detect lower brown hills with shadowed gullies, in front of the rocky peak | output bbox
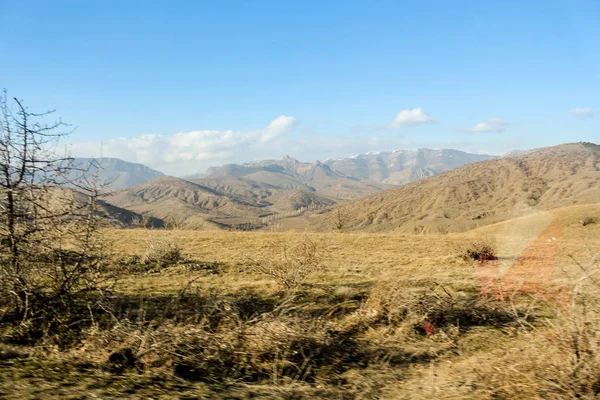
[103,176,336,230]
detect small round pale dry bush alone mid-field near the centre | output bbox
[251,236,327,289]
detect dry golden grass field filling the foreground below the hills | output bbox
[0,205,600,399]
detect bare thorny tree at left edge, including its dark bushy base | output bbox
[0,92,116,346]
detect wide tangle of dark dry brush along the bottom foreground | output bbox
[74,293,372,386]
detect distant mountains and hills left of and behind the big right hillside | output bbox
[95,149,495,229]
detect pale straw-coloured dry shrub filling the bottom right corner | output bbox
[412,254,600,399]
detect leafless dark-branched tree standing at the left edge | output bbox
[0,91,112,319]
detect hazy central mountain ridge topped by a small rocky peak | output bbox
[103,157,391,229]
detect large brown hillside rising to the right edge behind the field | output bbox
[313,143,600,233]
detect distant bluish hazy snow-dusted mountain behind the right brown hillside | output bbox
[324,149,497,185]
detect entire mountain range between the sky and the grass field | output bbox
[86,143,600,232]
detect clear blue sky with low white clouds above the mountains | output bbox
[0,0,600,175]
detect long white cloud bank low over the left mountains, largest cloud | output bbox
[71,115,299,176]
